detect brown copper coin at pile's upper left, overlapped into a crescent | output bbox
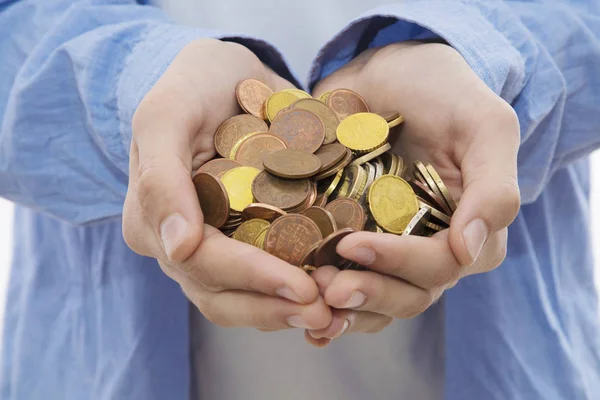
[215,114,269,158]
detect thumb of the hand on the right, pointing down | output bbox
[450,100,520,265]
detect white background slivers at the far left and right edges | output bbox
[0,152,600,335]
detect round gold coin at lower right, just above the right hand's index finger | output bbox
[368,175,419,234]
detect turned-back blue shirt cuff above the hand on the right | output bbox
[307,0,525,103]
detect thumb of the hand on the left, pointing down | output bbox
[130,110,204,262]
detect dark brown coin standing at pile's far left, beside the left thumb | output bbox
[194,172,229,228]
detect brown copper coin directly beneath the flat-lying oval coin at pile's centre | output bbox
[252,171,311,210]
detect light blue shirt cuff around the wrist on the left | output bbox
[117,24,300,166]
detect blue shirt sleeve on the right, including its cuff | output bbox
[309,0,600,203]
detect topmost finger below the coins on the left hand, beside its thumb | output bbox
[173,225,319,303]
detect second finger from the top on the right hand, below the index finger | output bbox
[325,271,442,318]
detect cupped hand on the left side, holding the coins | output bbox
[123,39,331,330]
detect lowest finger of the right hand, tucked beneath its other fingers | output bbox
[308,309,393,339]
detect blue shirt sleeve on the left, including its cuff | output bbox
[0,0,296,224]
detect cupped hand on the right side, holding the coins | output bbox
[306,42,520,345]
